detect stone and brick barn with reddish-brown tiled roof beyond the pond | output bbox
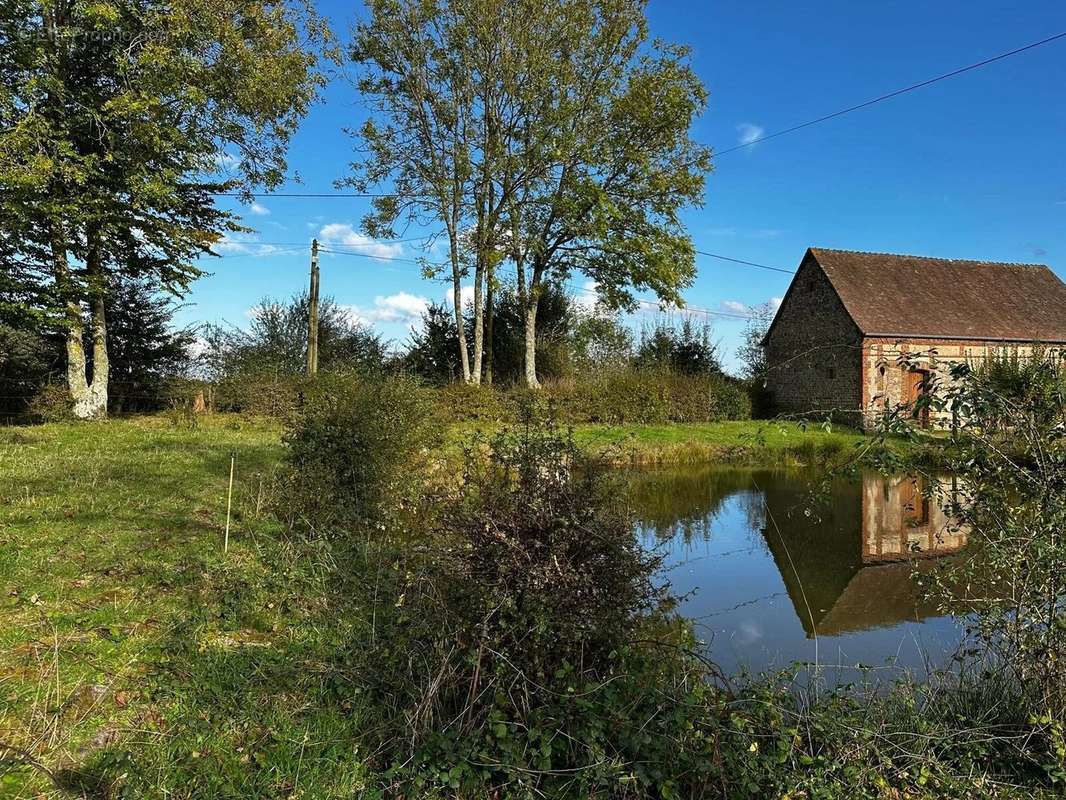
[762,247,1066,425]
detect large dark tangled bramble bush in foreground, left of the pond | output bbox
[361,422,713,797]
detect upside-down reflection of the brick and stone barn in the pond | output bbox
[763,476,966,636]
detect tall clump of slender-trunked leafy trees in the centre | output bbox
[352,0,710,385]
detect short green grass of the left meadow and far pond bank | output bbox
[0,416,861,798]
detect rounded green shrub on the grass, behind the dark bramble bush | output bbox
[280,375,439,531]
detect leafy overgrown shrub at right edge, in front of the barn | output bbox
[861,351,1066,721]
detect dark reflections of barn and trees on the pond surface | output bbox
[630,467,966,636]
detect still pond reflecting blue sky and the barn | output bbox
[630,467,966,681]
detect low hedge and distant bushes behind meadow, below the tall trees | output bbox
[0,281,750,422]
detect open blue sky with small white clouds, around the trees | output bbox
[179,0,1066,375]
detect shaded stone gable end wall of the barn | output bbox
[766,257,863,421]
